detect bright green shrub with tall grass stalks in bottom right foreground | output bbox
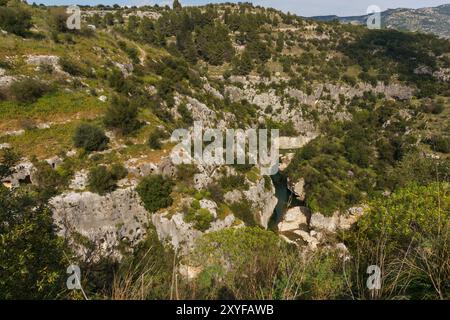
[346,183,450,299]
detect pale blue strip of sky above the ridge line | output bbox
[32,0,450,16]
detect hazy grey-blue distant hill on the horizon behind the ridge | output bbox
[313,4,450,38]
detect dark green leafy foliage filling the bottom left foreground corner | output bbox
[0,185,70,299]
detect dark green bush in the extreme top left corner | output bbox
[0,7,33,36]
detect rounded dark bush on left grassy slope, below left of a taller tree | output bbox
[73,123,109,151]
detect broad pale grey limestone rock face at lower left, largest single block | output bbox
[50,188,148,260]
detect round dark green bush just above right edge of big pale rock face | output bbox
[136,175,173,213]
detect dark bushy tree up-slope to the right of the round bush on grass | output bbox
[103,96,141,134]
